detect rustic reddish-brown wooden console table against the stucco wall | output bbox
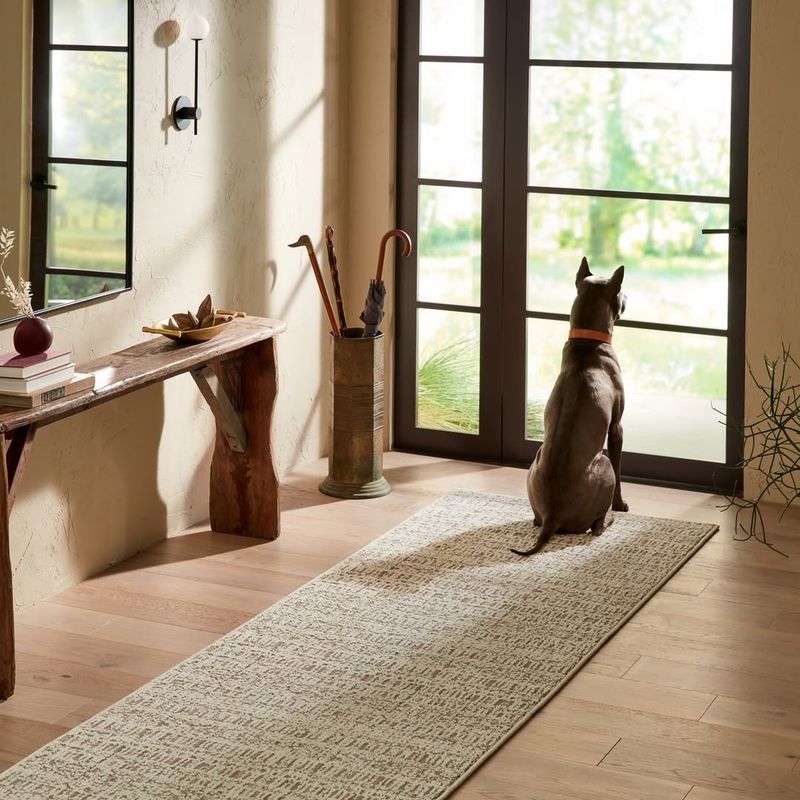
[0,317,286,700]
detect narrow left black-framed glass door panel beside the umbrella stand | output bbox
[394,0,506,458]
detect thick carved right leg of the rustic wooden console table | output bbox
[204,338,280,539]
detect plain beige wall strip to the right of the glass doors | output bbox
[745,0,800,495]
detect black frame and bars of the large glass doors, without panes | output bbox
[393,0,752,492]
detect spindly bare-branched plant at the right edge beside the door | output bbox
[721,344,800,555]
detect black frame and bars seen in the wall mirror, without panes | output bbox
[29,0,135,314]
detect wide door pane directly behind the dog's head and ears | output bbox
[528,194,728,328]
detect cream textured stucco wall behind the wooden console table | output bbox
[6,0,343,606]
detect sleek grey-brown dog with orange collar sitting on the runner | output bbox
[513,258,628,556]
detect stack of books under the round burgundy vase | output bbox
[0,349,94,408]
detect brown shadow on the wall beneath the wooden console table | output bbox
[12,384,167,606]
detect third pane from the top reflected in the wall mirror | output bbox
[47,164,126,273]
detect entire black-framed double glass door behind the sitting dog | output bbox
[394,0,750,490]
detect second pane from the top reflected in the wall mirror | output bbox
[50,50,128,161]
